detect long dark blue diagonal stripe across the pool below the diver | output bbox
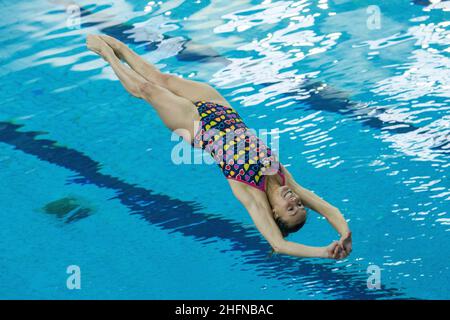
[0,121,410,299]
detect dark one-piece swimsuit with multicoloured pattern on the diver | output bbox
[192,101,285,191]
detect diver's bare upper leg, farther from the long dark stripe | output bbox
[101,35,228,104]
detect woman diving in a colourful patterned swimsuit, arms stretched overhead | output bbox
[87,35,352,259]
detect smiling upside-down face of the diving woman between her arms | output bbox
[273,186,306,226]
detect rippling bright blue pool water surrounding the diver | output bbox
[0,0,450,299]
